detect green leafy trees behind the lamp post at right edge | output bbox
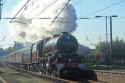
[96,37,125,63]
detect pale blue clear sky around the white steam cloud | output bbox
[0,0,125,48]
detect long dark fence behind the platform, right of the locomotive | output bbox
[84,56,125,69]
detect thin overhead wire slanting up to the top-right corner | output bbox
[85,0,125,17]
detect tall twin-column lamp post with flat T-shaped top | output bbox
[95,15,118,67]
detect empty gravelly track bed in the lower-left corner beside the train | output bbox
[0,61,48,83]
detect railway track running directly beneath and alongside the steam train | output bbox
[6,63,106,83]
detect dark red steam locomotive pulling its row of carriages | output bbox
[6,32,97,80]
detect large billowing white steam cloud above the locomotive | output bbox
[10,0,77,42]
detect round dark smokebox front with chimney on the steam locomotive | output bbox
[56,32,78,56]
